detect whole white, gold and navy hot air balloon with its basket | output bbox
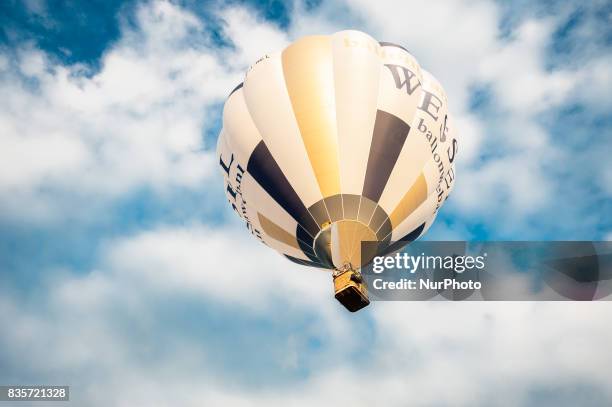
[217,30,457,311]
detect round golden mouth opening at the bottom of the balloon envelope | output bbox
[314,219,378,271]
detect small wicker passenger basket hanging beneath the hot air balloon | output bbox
[332,263,370,312]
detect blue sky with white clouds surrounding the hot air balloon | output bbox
[0,0,612,406]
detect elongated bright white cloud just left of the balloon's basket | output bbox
[101,227,331,308]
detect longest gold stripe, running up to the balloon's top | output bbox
[282,36,340,198]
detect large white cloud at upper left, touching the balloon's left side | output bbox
[0,1,274,220]
